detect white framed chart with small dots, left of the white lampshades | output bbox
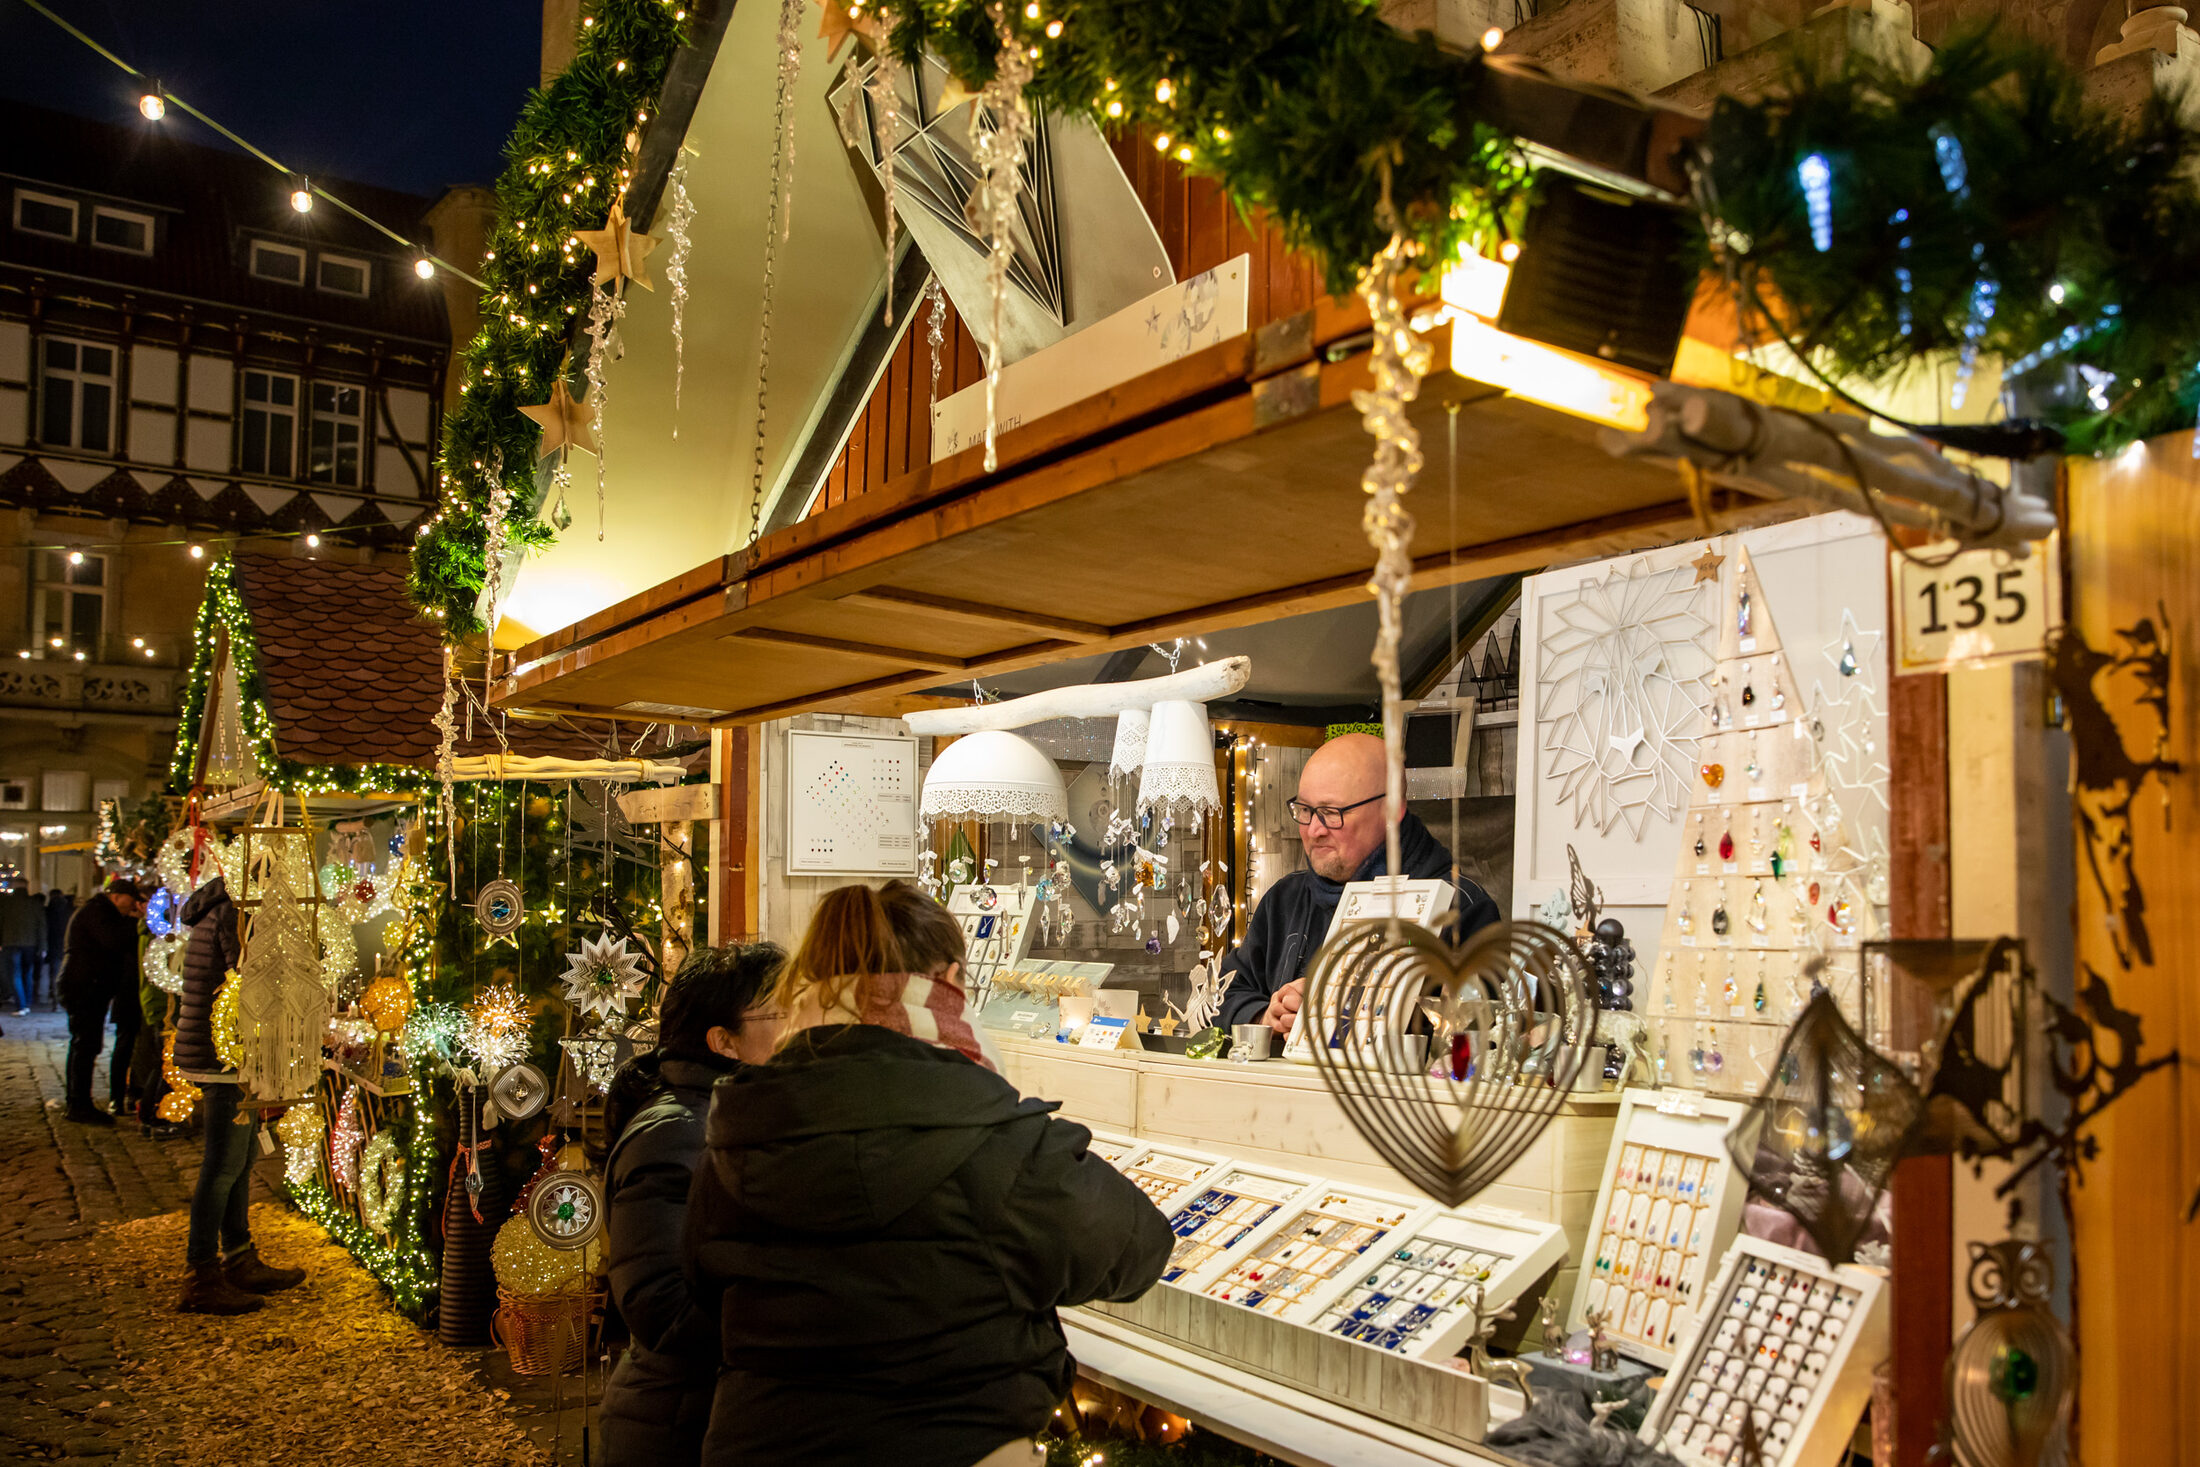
[788,732,917,875]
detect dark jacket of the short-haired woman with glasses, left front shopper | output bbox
[601,1054,737,1467]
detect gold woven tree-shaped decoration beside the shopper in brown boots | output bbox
[238,829,330,1102]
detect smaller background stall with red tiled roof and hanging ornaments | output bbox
[163,554,697,1370]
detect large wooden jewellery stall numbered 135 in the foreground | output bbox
[409,0,2200,1467]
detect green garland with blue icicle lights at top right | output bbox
[1703,31,2200,453]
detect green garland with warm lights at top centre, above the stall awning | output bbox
[873,0,1527,295]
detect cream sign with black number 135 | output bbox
[1890,537,2061,673]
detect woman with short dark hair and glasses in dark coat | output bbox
[598,941,785,1467]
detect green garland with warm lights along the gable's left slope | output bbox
[409,0,686,640]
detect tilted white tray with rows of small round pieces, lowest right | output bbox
[1641,1238,1888,1467]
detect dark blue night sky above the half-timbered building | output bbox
[0,0,541,196]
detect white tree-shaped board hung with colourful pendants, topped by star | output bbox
[1643,541,1863,1093]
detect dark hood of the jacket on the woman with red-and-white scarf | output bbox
[706,1025,1056,1234]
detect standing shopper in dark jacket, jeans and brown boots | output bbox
[176,875,306,1315]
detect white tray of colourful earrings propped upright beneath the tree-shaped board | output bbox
[1566,1091,1745,1366]
